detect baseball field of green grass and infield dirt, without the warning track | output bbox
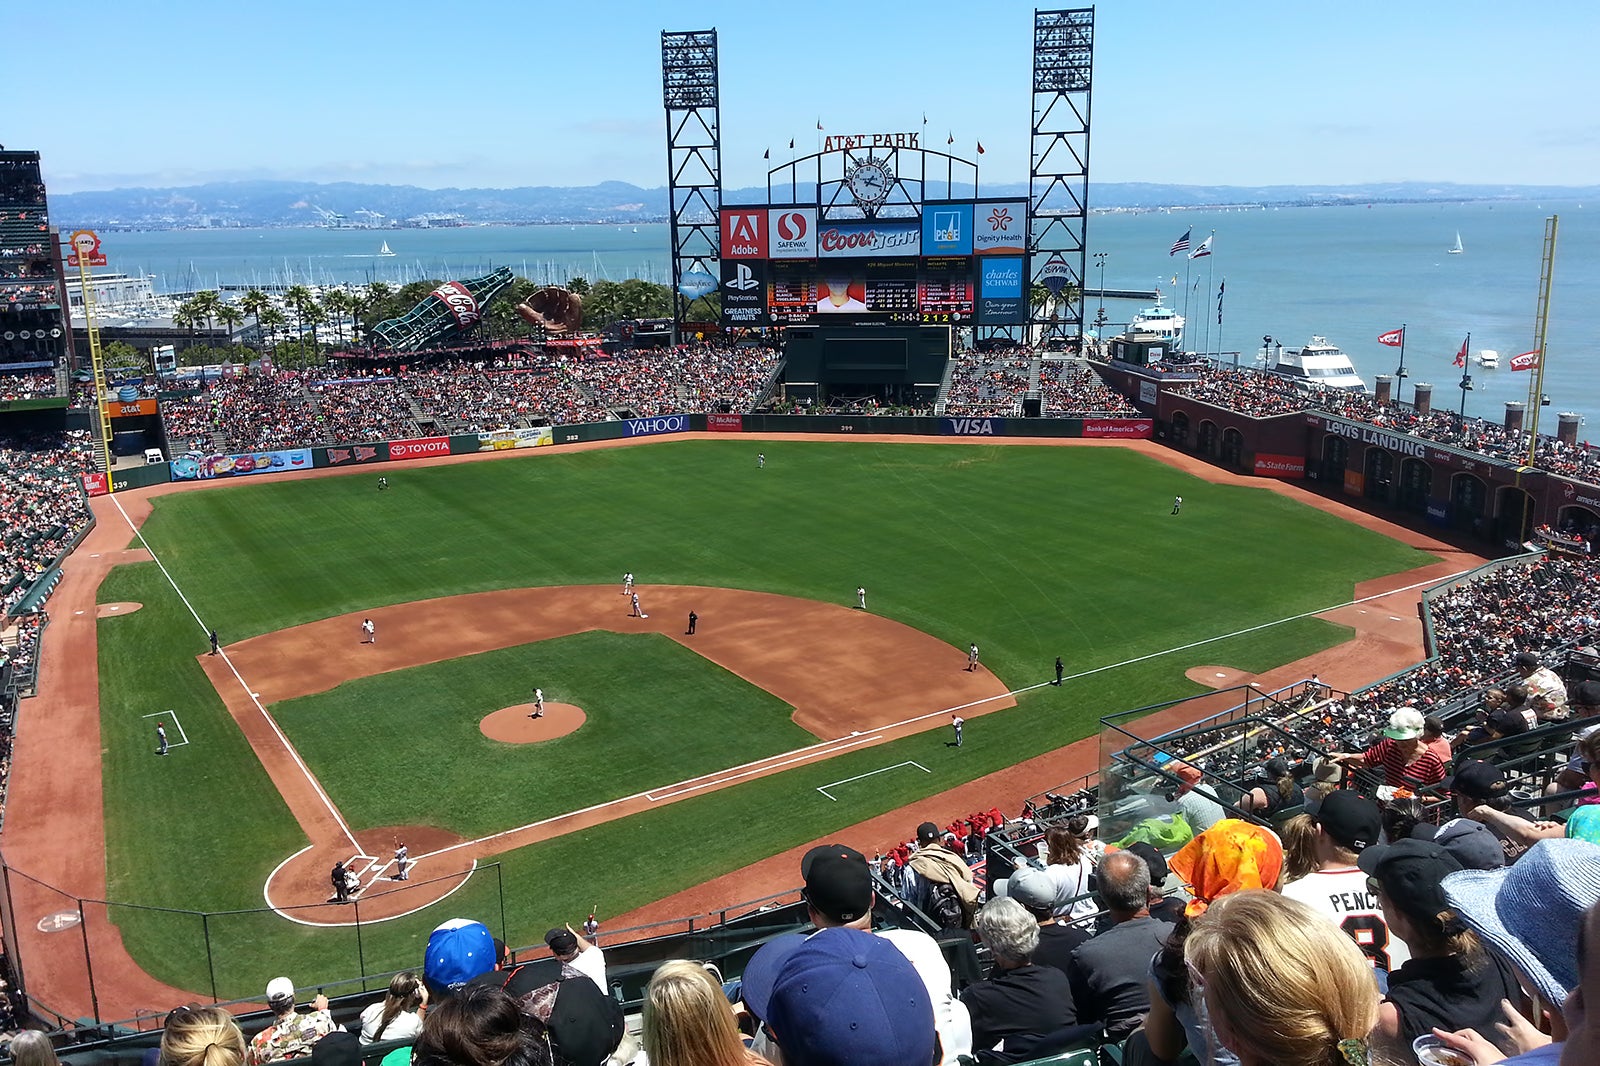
[75,440,1432,997]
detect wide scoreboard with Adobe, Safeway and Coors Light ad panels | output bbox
[720,200,1027,328]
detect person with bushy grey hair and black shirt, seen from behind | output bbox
[962,882,1075,1063]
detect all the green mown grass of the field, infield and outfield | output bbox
[99,440,1432,994]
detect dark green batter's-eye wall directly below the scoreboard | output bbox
[782,325,950,407]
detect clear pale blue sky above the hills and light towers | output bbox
[15,0,1600,192]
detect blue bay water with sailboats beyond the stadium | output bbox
[93,202,1600,425]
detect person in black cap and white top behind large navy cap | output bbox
[790,844,966,1066]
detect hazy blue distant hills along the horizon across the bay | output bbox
[50,181,1600,229]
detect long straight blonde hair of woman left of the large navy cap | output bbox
[643,959,766,1066]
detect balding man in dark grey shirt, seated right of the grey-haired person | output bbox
[1069,852,1173,1042]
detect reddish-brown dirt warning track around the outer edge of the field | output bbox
[0,434,1485,1018]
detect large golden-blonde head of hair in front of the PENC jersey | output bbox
[1184,890,1378,1066]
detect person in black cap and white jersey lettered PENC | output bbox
[1283,787,1421,981]
